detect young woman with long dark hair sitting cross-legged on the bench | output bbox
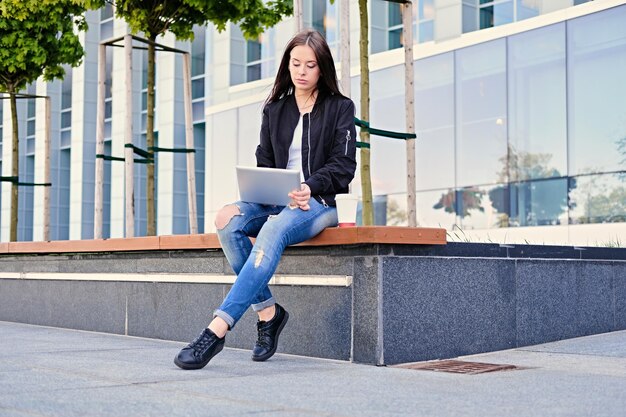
[174,30,356,369]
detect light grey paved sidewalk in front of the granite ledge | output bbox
[0,322,626,417]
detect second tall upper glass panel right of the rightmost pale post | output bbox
[456,39,507,187]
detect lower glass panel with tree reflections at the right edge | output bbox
[569,174,626,224]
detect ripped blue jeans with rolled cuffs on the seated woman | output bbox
[214,198,337,329]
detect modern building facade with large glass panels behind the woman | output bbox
[0,0,626,243]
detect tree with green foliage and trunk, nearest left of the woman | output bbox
[115,0,292,236]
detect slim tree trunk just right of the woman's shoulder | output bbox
[359,0,374,226]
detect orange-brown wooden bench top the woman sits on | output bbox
[0,226,446,255]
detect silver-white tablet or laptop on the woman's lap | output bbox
[236,165,300,206]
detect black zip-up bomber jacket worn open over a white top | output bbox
[256,94,356,206]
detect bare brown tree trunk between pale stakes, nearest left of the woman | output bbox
[146,36,156,236]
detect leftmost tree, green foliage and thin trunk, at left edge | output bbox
[0,0,90,241]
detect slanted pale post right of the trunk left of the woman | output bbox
[183,53,198,234]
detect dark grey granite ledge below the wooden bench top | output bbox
[0,240,626,365]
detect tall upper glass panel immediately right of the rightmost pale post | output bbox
[414,52,454,190]
